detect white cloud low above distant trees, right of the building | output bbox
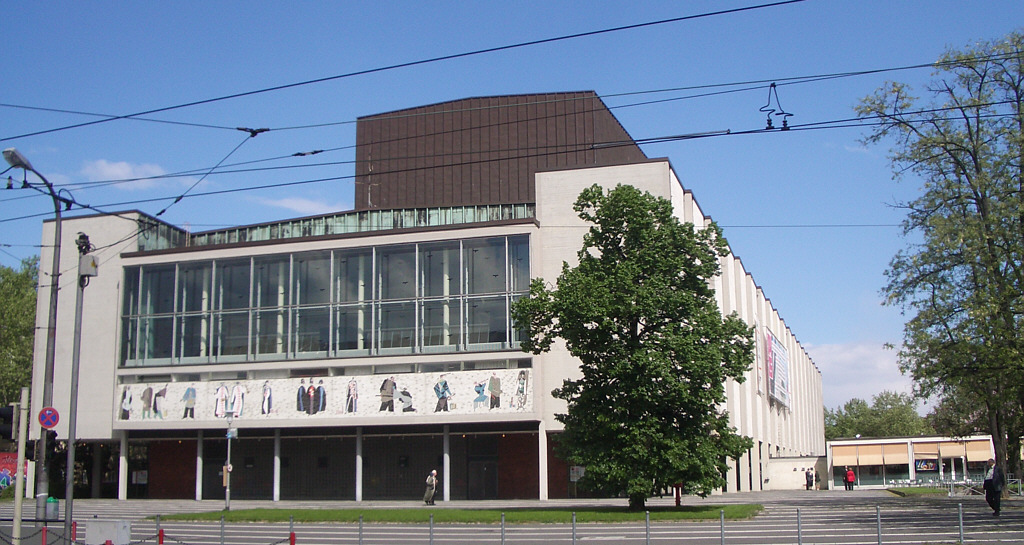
[806,342,922,411]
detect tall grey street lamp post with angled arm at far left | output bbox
[3,148,65,520]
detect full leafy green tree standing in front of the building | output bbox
[513,185,754,508]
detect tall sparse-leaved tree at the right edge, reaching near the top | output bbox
[857,32,1024,473]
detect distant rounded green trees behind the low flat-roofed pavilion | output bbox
[825,390,935,441]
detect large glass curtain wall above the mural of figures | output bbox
[121,235,530,367]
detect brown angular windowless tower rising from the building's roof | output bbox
[354,91,647,210]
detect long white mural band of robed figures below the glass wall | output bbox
[117,369,532,425]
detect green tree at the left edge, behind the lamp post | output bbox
[0,257,39,406]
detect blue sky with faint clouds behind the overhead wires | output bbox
[0,0,1024,408]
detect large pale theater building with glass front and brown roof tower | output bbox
[33,92,825,501]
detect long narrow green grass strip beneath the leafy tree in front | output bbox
[161,504,763,523]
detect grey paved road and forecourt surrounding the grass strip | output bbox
[0,491,1024,545]
